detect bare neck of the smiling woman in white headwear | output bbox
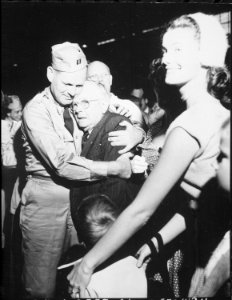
[180,69,212,108]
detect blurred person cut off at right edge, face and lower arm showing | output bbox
[188,118,231,297]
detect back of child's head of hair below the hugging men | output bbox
[73,194,118,248]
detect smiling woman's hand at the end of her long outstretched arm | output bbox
[67,260,92,299]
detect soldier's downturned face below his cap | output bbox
[51,68,86,106]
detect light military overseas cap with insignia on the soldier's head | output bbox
[52,42,87,73]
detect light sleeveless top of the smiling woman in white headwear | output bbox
[166,97,229,198]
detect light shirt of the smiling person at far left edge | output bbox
[1,119,21,167]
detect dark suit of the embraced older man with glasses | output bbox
[71,111,142,223]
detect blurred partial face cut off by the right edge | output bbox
[217,119,230,192]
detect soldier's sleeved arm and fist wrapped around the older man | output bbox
[22,106,131,181]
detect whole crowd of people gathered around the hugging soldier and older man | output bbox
[1,13,230,300]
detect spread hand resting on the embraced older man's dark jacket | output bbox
[108,121,144,154]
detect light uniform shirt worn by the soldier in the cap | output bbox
[22,88,106,180]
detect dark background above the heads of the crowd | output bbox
[1,1,231,103]
